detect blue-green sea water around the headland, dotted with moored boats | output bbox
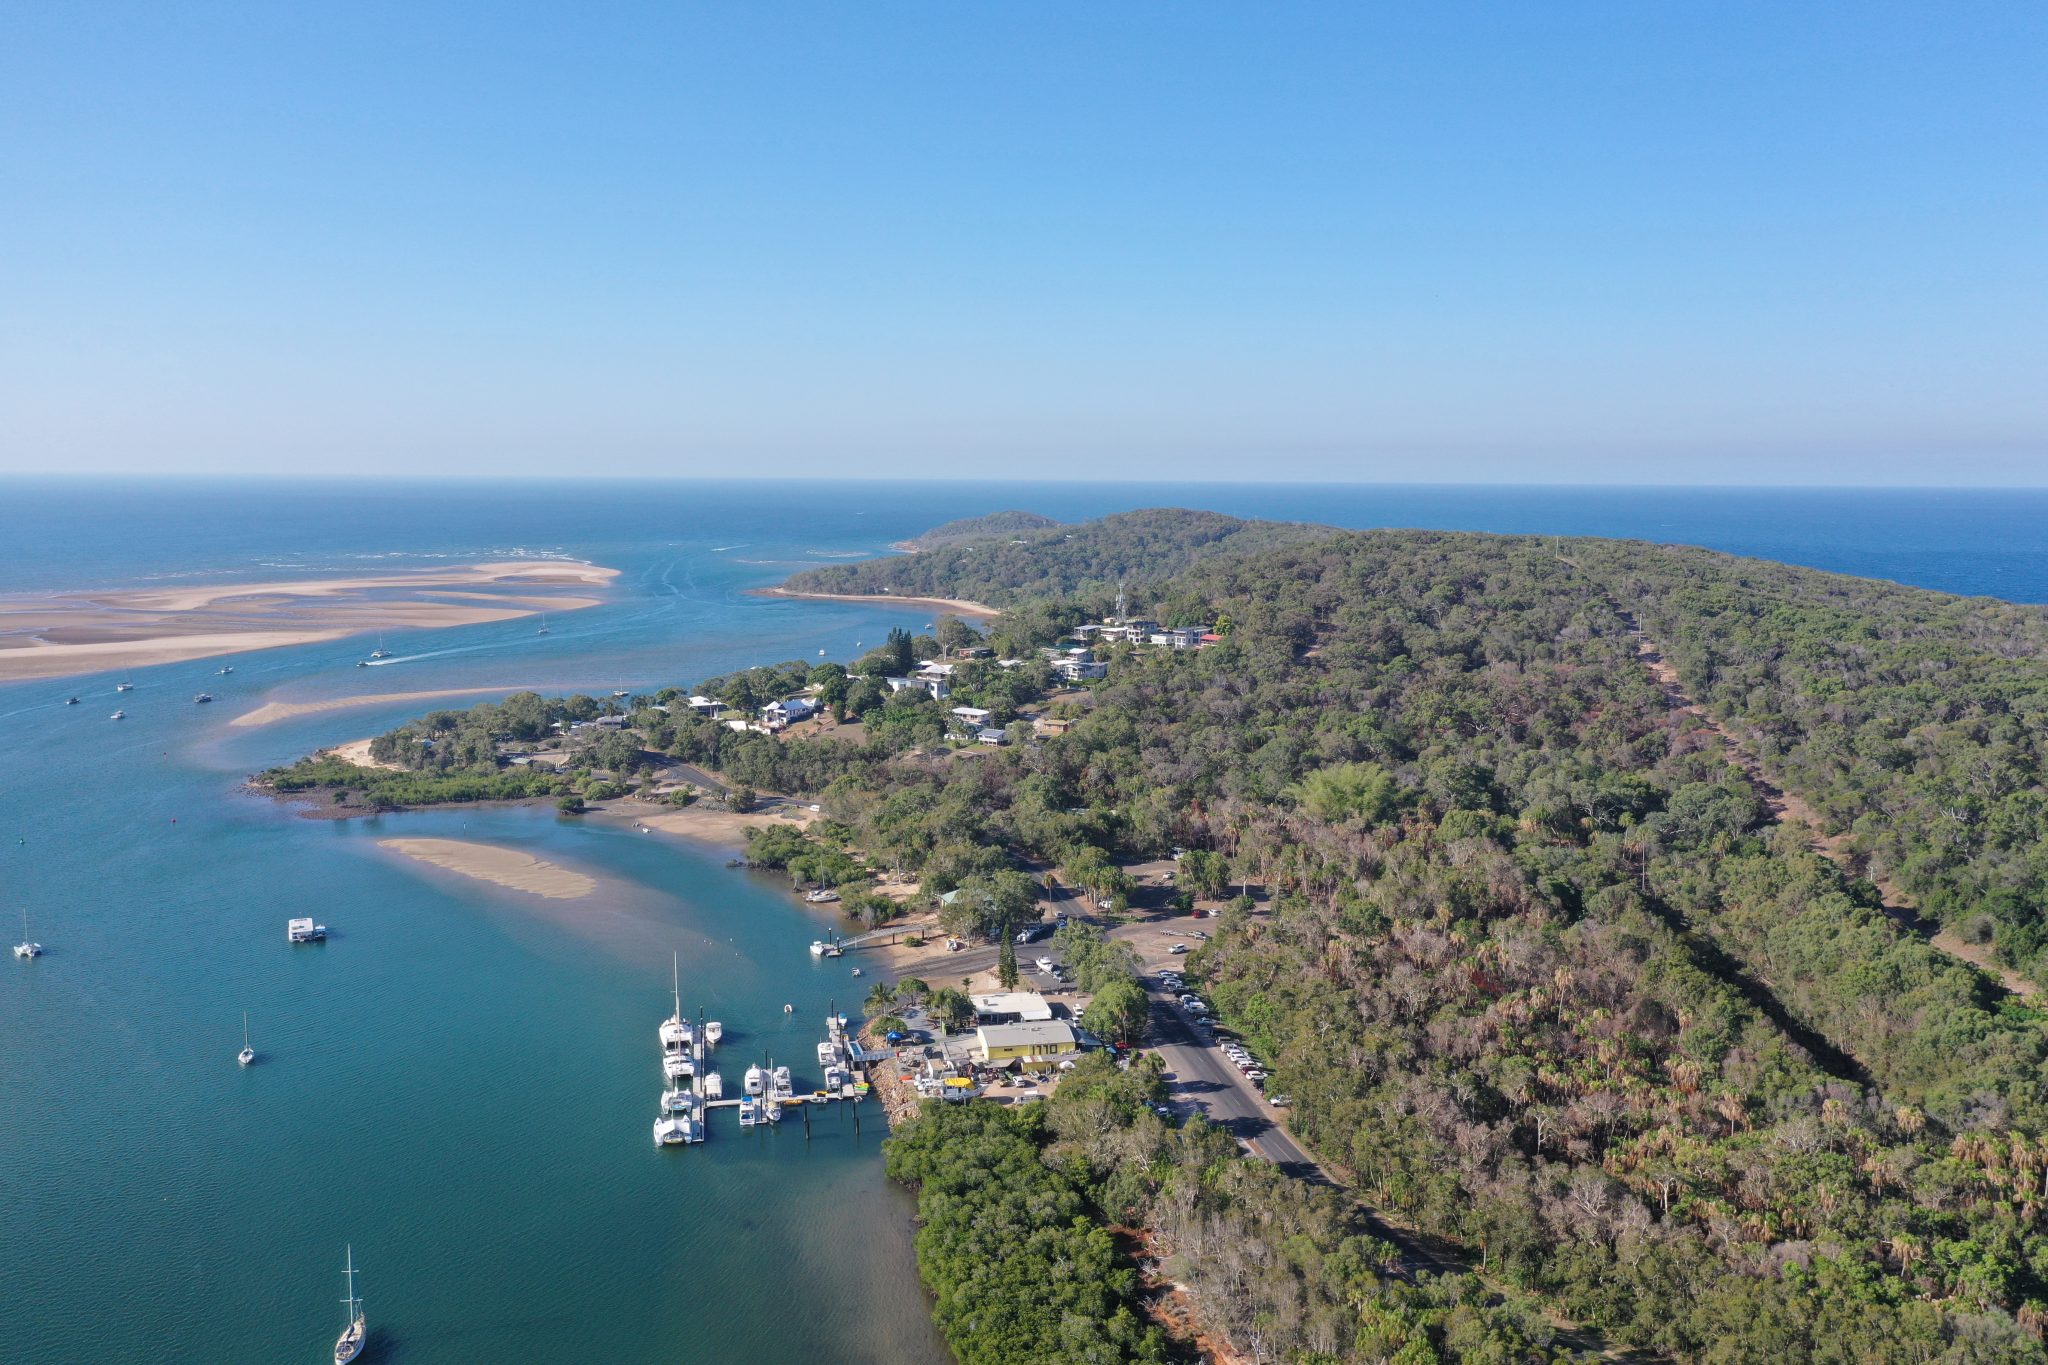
[0,474,2048,1365]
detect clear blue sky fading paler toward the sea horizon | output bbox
[0,0,2048,483]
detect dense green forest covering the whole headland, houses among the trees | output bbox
[264,512,2048,1365]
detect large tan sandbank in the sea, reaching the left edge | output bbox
[0,559,618,681]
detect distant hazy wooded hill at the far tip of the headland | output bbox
[784,508,1335,606]
